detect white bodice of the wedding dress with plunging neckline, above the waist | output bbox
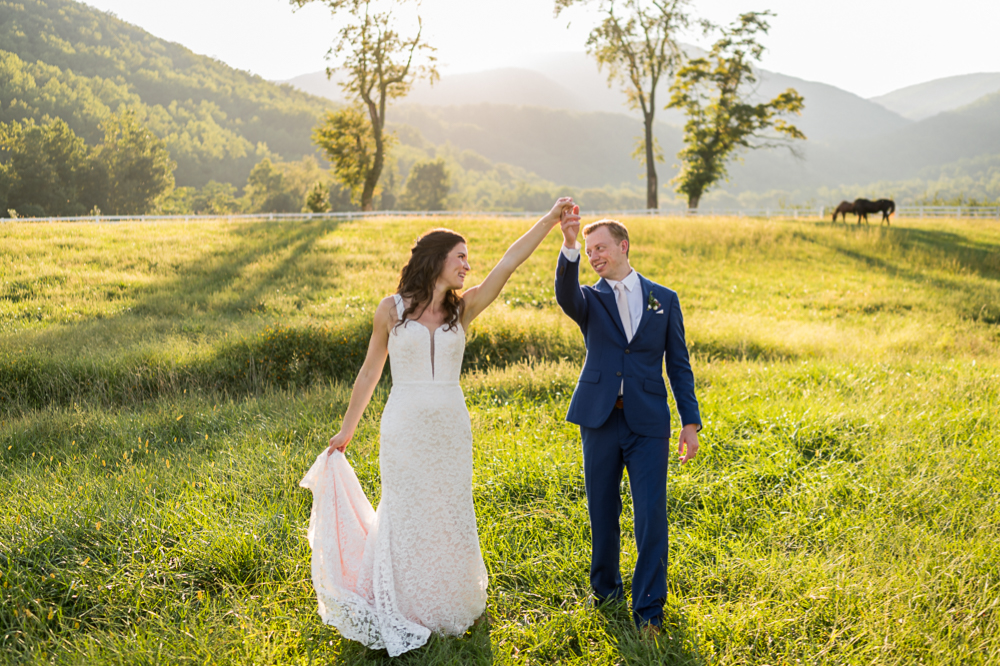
[389,294,465,386]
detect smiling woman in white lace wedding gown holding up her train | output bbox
[300,197,580,656]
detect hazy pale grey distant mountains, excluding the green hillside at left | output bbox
[287,53,1000,196]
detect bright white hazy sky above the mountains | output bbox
[87,0,1000,97]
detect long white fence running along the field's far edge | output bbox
[0,206,1000,223]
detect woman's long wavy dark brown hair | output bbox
[393,229,465,331]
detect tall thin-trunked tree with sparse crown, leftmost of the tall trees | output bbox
[290,0,438,210]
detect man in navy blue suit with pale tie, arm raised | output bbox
[556,218,701,634]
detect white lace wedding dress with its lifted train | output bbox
[299,294,487,656]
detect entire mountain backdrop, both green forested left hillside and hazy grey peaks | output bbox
[0,0,1000,205]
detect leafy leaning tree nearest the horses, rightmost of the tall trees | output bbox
[667,12,806,209]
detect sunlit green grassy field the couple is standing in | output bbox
[0,218,1000,665]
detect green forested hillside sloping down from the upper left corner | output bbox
[0,0,331,187]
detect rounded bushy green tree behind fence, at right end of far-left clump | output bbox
[97,109,177,215]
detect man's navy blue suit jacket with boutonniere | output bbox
[556,252,701,437]
